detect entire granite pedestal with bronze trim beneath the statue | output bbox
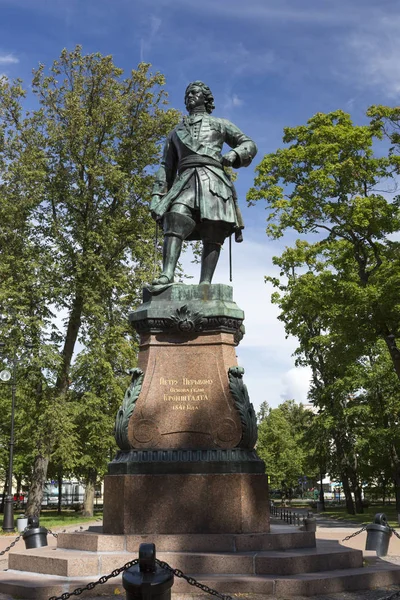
[104,284,269,534]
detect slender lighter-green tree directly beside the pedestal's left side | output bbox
[72,313,137,516]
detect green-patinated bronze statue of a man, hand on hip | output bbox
[151,81,257,286]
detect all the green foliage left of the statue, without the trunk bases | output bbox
[0,46,178,504]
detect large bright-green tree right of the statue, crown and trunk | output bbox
[249,111,400,510]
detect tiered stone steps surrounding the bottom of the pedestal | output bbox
[0,526,400,600]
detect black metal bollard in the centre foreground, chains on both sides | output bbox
[122,544,174,600]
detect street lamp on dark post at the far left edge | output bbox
[0,342,33,531]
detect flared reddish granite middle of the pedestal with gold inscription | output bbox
[128,333,241,448]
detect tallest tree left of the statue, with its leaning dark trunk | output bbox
[0,46,177,514]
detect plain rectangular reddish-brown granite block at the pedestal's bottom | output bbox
[103,473,269,534]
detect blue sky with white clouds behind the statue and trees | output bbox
[0,0,400,406]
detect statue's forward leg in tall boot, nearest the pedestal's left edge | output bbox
[153,212,196,285]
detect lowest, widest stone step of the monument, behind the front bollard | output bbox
[0,559,400,600]
